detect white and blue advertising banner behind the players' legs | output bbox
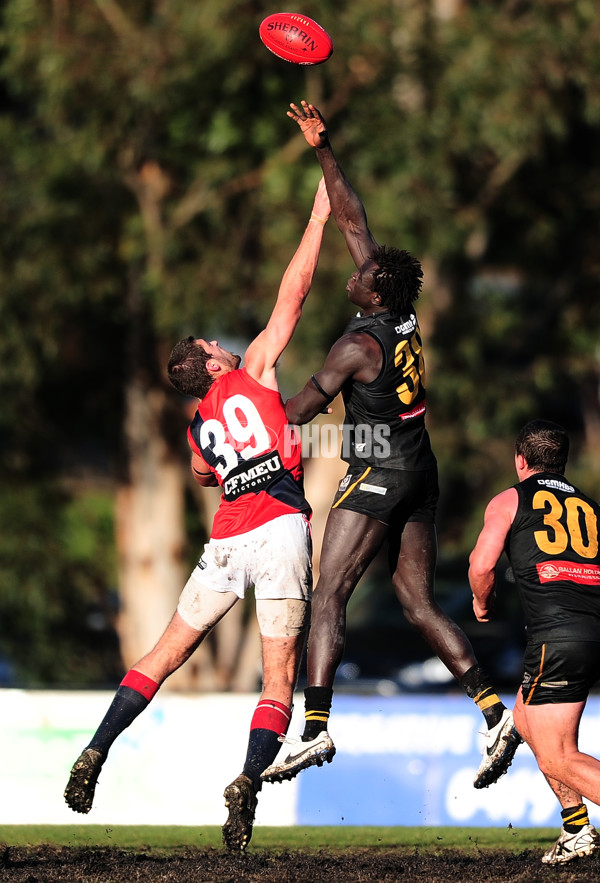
[0,690,600,827]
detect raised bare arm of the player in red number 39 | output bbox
[244,178,330,389]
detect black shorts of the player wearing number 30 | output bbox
[521,639,600,705]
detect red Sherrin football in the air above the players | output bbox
[258,12,333,64]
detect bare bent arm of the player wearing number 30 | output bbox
[469,488,518,622]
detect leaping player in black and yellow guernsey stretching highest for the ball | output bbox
[262,101,520,788]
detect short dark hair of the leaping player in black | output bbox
[371,245,423,316]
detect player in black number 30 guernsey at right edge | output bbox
[469,420,600,865]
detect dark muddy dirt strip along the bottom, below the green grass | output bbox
[0,846,600,883]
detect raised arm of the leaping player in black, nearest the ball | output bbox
[288,101,377,268]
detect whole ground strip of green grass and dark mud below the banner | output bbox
[0,825,600,883]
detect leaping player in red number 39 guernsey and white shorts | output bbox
[65,180,329,851]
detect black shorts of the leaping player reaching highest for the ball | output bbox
[331,464,440,526]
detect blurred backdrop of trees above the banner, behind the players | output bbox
[0,0,600,689]
